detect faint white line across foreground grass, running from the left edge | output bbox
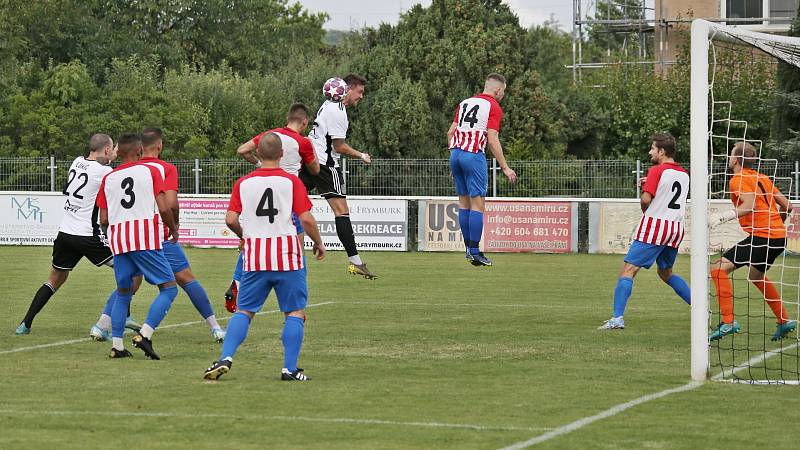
[0,409,548,431]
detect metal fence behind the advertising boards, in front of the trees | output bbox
[0,158,800,200]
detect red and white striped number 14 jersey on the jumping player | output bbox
[450,94,503,153]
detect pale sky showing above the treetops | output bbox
[298,0,572,31]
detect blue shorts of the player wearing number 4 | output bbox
[237,269,308,313]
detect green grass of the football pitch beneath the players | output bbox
[0,247,800,449]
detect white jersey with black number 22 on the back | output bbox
[58,156,111,236]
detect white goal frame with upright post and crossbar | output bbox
[690,19,800,381]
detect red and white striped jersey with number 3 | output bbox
[97,161,164,255]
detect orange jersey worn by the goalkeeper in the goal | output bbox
[729,168,786,238]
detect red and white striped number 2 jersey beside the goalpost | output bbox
[633,163,689,248]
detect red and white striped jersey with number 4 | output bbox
[228,168,311,272]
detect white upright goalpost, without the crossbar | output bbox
[690,20,711,381]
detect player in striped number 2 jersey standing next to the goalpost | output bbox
[598,133,691,330]
